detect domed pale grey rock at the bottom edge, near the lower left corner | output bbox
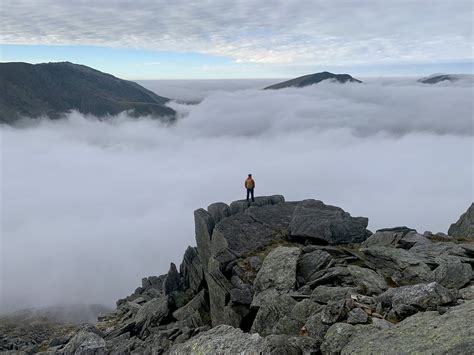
[62,325,106,355]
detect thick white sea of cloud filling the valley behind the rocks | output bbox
[0,80,474,310]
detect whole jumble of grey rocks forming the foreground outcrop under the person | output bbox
[0,196,474,354]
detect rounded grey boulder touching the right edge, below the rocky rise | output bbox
[432,256,473,289]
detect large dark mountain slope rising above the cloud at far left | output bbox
[0,62,175,123]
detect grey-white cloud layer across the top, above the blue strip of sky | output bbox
[0,0,473,65]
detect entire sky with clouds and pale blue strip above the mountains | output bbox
[0,0,474,80]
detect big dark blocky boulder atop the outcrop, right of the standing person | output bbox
[290,200,370,244]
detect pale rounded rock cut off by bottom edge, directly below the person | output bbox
[170,325,265,355]
